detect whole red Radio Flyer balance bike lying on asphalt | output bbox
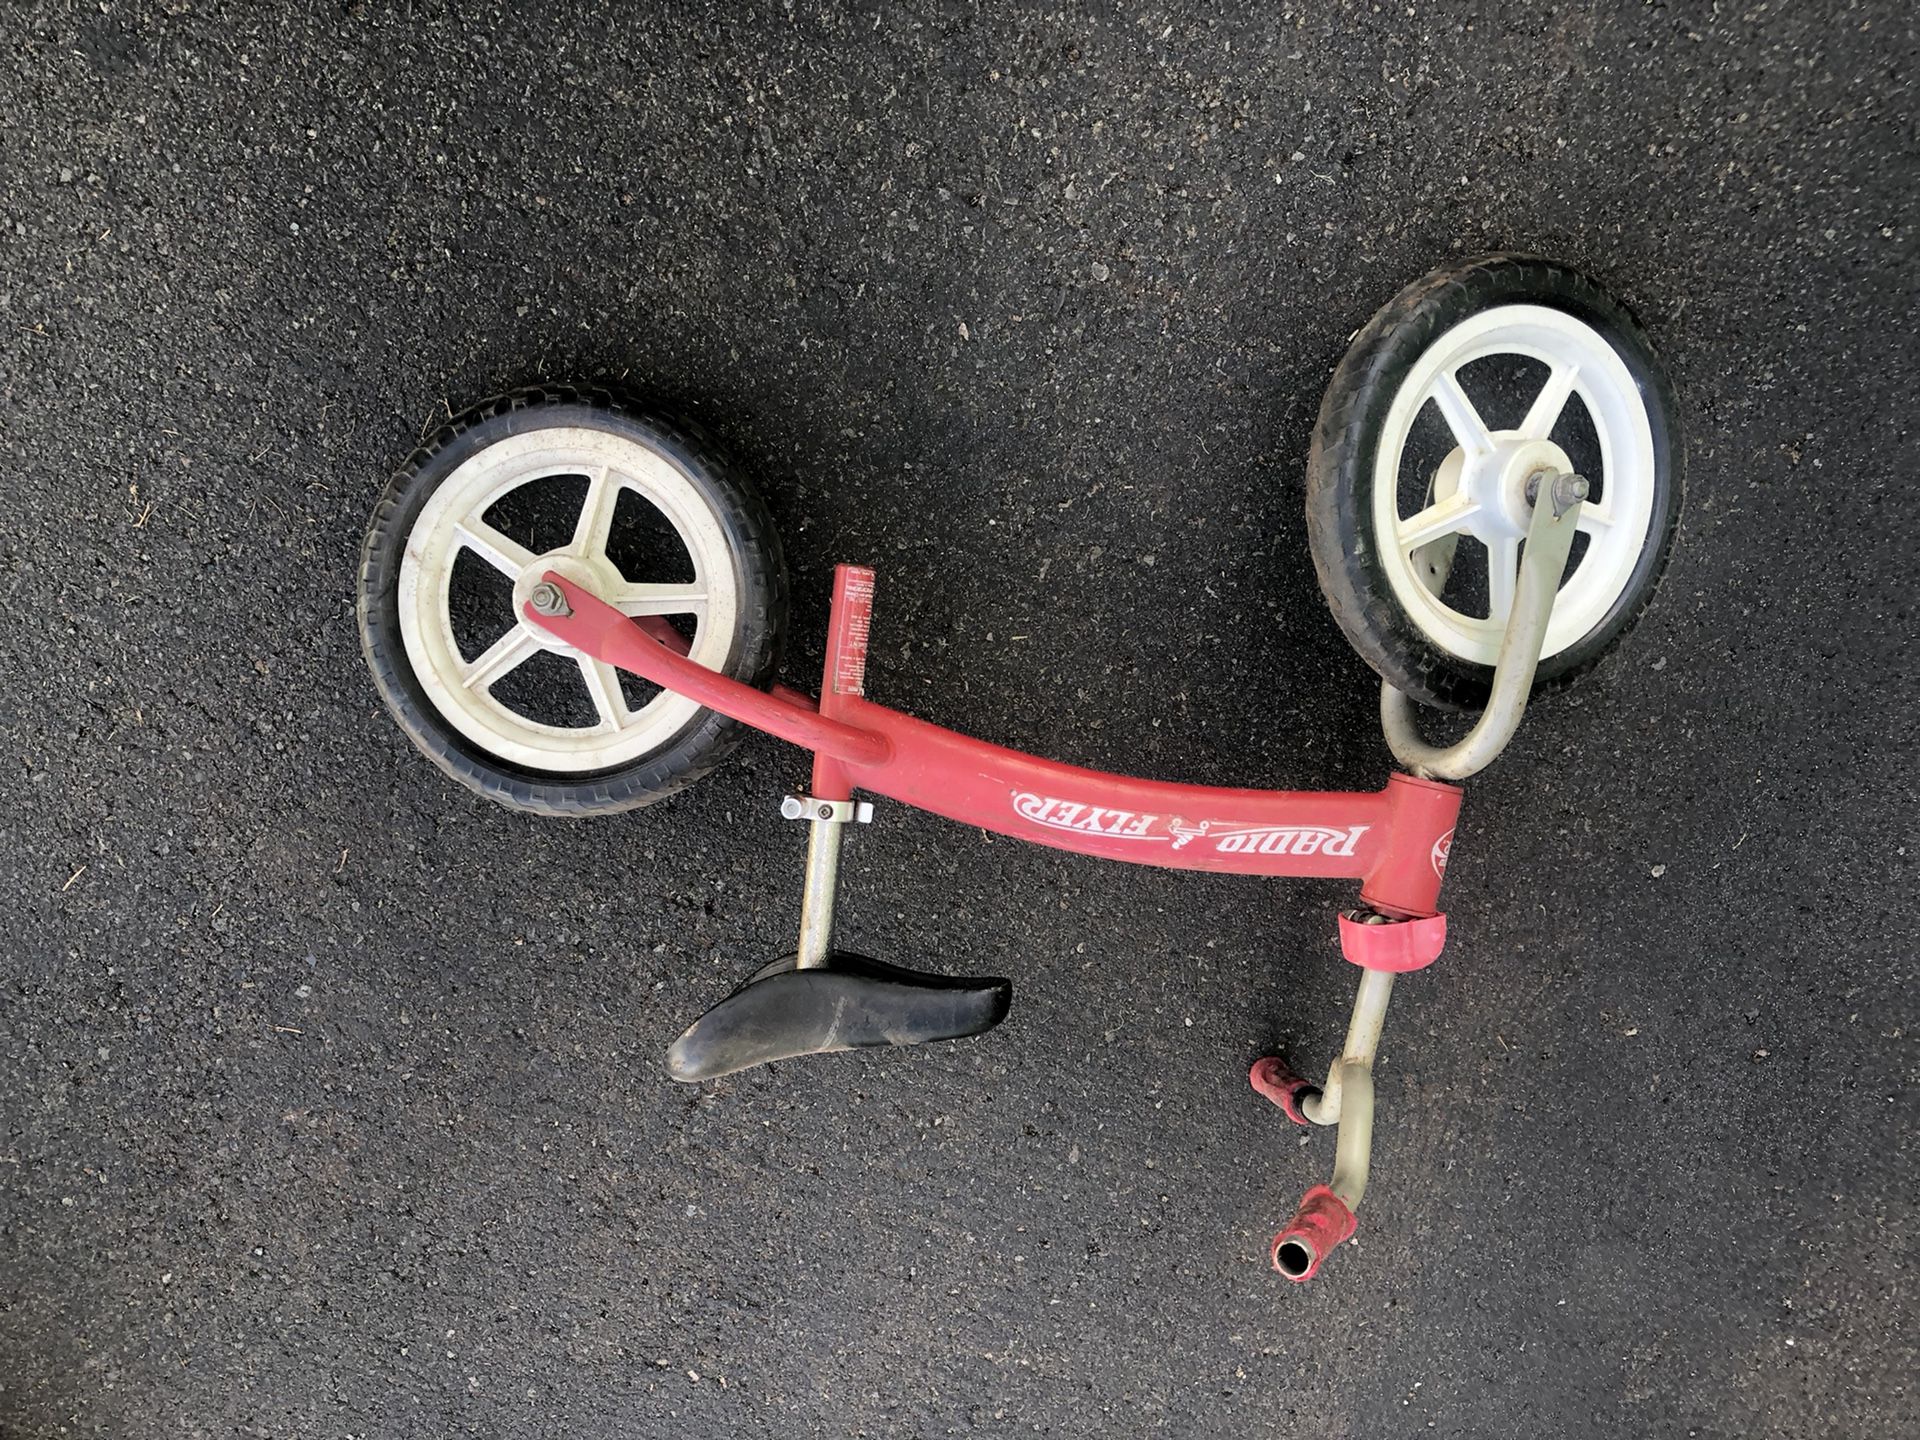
[359,255,1682,1281]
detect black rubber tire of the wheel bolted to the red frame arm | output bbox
[357,386,787,816]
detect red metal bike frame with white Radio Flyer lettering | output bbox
[524,564,1461,917]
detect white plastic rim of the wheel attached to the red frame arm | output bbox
[399,426,739,774]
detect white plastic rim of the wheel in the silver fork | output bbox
[1373,305,1655,664]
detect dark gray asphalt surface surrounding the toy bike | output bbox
[0,0,1920,1438]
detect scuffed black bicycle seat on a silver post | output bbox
[666,950,1014,1081]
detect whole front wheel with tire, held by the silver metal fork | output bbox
[1308,255,1682,710]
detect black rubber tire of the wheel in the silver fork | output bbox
[1308,255,1684,710]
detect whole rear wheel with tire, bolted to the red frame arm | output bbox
[359,388,787,814]
